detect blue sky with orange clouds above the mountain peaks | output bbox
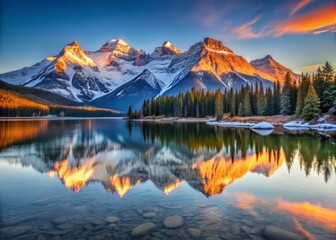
[0,0,336,73]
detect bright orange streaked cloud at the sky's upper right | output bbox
[232,3,336,39]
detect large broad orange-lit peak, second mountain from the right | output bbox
[161,38,275,95]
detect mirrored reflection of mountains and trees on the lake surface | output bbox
[0,120,336,197]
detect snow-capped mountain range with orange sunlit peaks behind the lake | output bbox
[0,38,299,111]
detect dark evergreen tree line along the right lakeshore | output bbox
[127,62,336,121]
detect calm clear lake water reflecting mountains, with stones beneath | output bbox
[0,119,336,239]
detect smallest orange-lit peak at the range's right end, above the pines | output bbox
[251,55,300,84]
